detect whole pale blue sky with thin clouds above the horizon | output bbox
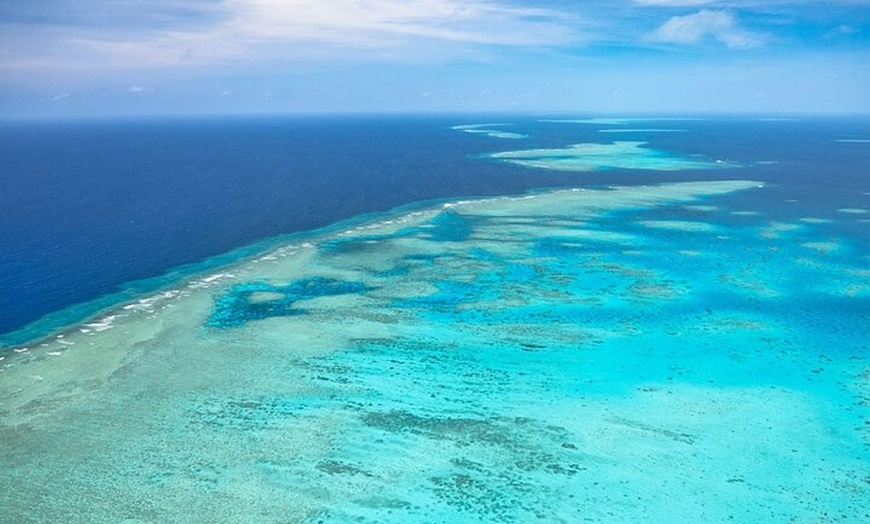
[0,0,870,118]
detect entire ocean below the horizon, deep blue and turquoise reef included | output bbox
[0,115,870,523]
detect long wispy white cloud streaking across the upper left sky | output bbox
[4,0,580,74]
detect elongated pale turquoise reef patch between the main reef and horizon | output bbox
[487,141,735,171]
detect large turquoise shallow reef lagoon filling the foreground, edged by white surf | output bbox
[0,175,870,523]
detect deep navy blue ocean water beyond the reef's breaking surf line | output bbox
[0,116,870,343]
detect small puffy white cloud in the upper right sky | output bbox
[652,9,762,49]
